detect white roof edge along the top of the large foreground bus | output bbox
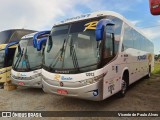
[54,11,151,42]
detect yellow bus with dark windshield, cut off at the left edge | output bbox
[0,29,33,84]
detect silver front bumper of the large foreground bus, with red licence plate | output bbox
[42,78,103,101]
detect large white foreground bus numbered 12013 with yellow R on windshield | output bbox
[42,11,154,101]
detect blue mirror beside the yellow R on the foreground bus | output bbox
[95,19,114,41]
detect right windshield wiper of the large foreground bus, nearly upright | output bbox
[70,38,79,71]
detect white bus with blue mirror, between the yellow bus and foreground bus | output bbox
[11,31,50,88]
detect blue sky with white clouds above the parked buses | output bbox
[0,0,160,54]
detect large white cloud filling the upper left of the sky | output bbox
[0,0,88,31]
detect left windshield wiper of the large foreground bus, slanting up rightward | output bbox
[50,39,66,68]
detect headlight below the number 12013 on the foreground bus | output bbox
[79,74,104,85]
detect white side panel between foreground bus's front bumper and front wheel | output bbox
[103,55,123,99]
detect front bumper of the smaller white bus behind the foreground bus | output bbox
[11,76,42,88]
